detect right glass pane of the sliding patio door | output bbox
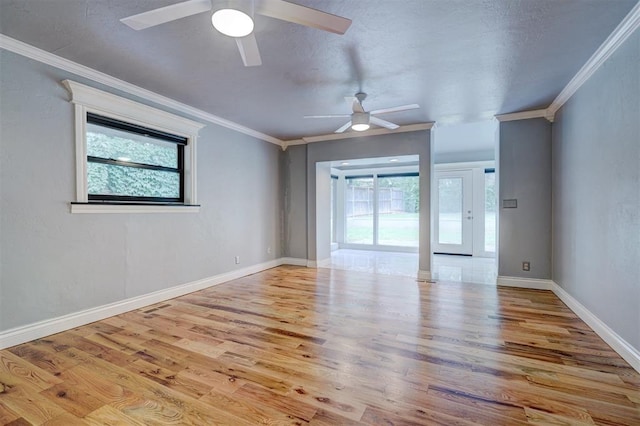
[378,176,420,247]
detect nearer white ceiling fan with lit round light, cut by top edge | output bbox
[120,0,351,67]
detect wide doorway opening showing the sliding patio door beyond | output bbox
[317,155,420,277]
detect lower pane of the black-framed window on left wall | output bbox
[87,162,180,198]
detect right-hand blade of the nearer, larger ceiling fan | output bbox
[256,0,351,34]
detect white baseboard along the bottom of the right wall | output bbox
[551,281,640,373]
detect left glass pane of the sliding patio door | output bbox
[344,178,373,244]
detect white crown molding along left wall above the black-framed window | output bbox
[0,34,284,147]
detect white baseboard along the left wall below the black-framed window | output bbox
[0,258,284,349]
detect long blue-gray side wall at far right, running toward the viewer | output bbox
[553,31,640,350]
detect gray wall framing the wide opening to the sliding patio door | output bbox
[302,130,431,271]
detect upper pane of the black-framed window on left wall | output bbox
[87,123,178,168]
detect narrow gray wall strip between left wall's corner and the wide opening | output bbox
[281,145,307,260]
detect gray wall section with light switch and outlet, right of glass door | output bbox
[498,118,551,279]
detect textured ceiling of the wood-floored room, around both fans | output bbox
[0,0,636,140]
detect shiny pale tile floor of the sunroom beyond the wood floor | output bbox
[322,249,497,285]
